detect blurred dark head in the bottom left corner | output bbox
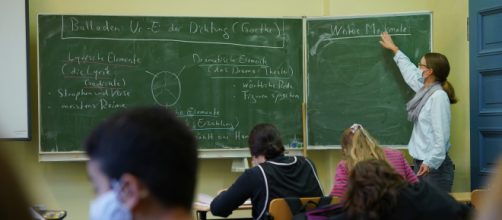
[0,149,33,220]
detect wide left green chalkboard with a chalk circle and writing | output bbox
[38,15,303,152]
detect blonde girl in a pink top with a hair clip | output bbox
[330,124,418,197]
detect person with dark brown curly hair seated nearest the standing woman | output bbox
[330,159,469,220]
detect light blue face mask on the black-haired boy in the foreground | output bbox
[89,187,132,220]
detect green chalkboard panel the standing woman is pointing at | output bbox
[307,13,431,146]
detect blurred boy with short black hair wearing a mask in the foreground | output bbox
[85,107,197,220]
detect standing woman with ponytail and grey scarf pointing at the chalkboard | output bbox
[380,32,457,192]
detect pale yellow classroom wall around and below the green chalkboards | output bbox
[1,0,470,220]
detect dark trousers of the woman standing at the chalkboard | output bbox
[413,154,455,192]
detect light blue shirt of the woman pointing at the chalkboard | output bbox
[394,51,451,169]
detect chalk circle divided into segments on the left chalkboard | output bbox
[151,71,181,106]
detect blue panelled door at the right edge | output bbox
[469,0,502,189]
